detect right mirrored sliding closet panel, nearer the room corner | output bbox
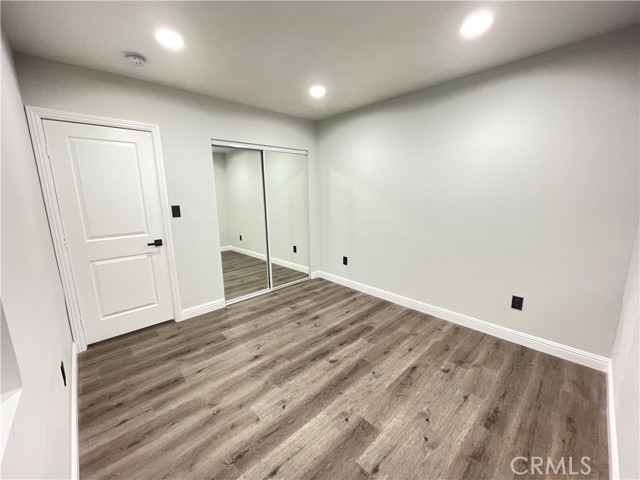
[265,151,309,287]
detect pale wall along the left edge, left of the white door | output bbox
[0,34,72,479]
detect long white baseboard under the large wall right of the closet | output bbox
[314,271,609,372]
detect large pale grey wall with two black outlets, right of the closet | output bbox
[318,29,640,357]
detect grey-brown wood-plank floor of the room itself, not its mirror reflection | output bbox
[79,280,608,480]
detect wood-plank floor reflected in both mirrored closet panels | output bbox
[221,251,308,300]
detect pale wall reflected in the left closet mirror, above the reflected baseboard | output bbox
[226,150,267,256]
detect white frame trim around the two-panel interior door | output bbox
[25,106,181,352]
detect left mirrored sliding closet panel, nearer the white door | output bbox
[213,147,269,300]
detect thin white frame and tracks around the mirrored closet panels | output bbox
[211,138,311,305]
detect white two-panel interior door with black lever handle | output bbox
[43,120,174,343]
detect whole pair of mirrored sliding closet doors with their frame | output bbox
[212,141,309,303]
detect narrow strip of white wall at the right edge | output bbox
[609,231,640,480]
